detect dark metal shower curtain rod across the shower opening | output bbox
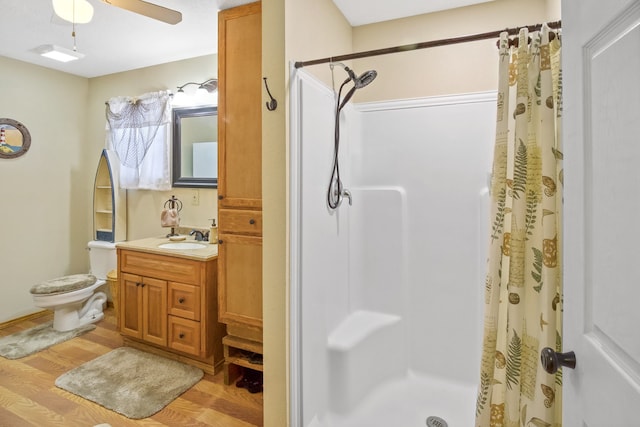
[295,21,562,68]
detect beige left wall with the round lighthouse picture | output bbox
[0,57,90,322]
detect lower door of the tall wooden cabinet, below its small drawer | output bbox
[218,234,262,329]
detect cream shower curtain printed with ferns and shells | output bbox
[476,26,562,427]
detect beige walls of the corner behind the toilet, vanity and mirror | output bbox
[0,55,218,322]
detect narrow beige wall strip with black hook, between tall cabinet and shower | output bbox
[262,0,288,426]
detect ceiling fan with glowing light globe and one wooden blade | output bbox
[53,0,182,25]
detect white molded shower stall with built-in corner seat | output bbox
[290,70,496,427]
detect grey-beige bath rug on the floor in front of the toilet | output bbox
[0,321,96,359]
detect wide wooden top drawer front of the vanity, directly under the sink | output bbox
[118,250,202,285]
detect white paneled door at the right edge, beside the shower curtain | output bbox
[562,0,640,427]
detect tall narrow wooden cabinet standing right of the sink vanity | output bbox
[218,2,263,383]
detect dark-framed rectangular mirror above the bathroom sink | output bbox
[172,106,218,188]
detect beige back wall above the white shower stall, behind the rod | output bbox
[353,0,560,102]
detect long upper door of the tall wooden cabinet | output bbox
[218,2,263,208]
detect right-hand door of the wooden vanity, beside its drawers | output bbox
[142,277,167,346]
